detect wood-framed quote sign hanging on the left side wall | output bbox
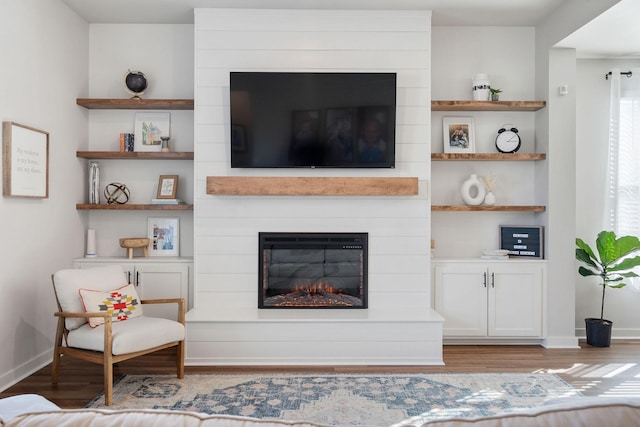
[2,122,49,199]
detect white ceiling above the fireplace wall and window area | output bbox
[62,0,640,58]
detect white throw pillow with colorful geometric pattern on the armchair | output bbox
[80,284,142,328]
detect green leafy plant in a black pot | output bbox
[576,231,640,347]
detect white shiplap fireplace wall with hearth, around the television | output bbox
[186,9,442,365]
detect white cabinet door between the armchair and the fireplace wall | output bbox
[134,262,189,320]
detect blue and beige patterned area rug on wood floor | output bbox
[87,373,580,426]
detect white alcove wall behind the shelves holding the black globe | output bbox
[85,24,194,257]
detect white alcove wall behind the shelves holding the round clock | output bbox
[431,26,544,258]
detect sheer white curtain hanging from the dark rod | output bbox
[604,69,640,236]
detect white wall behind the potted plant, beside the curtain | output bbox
[574,59,640,338]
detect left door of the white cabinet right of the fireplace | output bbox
[434,263,487,336]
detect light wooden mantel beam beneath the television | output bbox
[207,176,418,196]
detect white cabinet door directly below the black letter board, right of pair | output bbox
[489,263,543,337]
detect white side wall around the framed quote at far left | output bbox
[0,0,89,389]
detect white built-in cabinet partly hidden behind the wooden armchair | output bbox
[73,258,193,320]
